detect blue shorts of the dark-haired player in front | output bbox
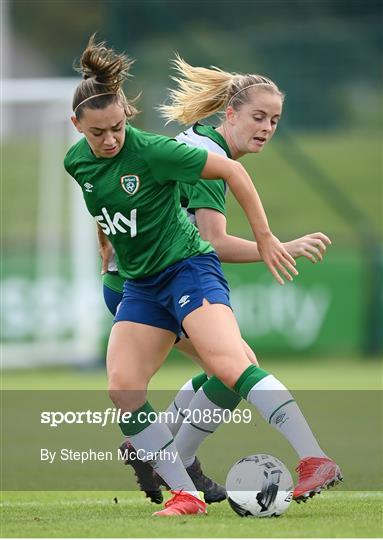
[114,253,231,335]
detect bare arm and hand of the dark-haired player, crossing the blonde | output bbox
[201,152,298,285]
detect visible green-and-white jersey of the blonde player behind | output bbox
[176,123,231,215]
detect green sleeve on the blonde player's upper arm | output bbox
[187,180,226,216]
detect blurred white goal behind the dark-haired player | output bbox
[0,78,110,368]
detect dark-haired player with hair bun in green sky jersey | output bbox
[65,38,338,516]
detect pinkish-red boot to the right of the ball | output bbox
[293,457,343,503]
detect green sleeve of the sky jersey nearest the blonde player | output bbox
[146,137,208,184]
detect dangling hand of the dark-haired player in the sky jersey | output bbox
[257,233,299,285]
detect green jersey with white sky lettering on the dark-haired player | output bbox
[64,126,214,279]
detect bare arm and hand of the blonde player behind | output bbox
[195,208,331,263]
